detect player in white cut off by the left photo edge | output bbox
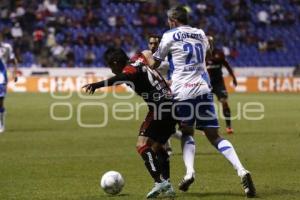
[0,33,17,133]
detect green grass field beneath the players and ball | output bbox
[0,94,300,200]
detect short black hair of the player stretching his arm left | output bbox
[103,47,129,66]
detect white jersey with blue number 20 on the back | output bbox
[153,26,211,101]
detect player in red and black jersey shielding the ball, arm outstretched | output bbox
[83,48,176,198]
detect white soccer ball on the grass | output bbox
[100,171,125,195]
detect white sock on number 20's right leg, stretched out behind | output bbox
[218,140,246,176]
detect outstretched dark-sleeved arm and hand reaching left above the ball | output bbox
[82,73,129,94]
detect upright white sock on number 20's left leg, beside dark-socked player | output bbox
[181,136,196,174]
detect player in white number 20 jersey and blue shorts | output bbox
[152,6,256,197]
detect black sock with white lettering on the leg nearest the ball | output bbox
[138,146,162,183]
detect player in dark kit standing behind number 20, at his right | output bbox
[206,37,237,134]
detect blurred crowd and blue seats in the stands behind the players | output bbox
[0,0,300,67]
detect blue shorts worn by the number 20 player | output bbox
[175,93,220,130]
